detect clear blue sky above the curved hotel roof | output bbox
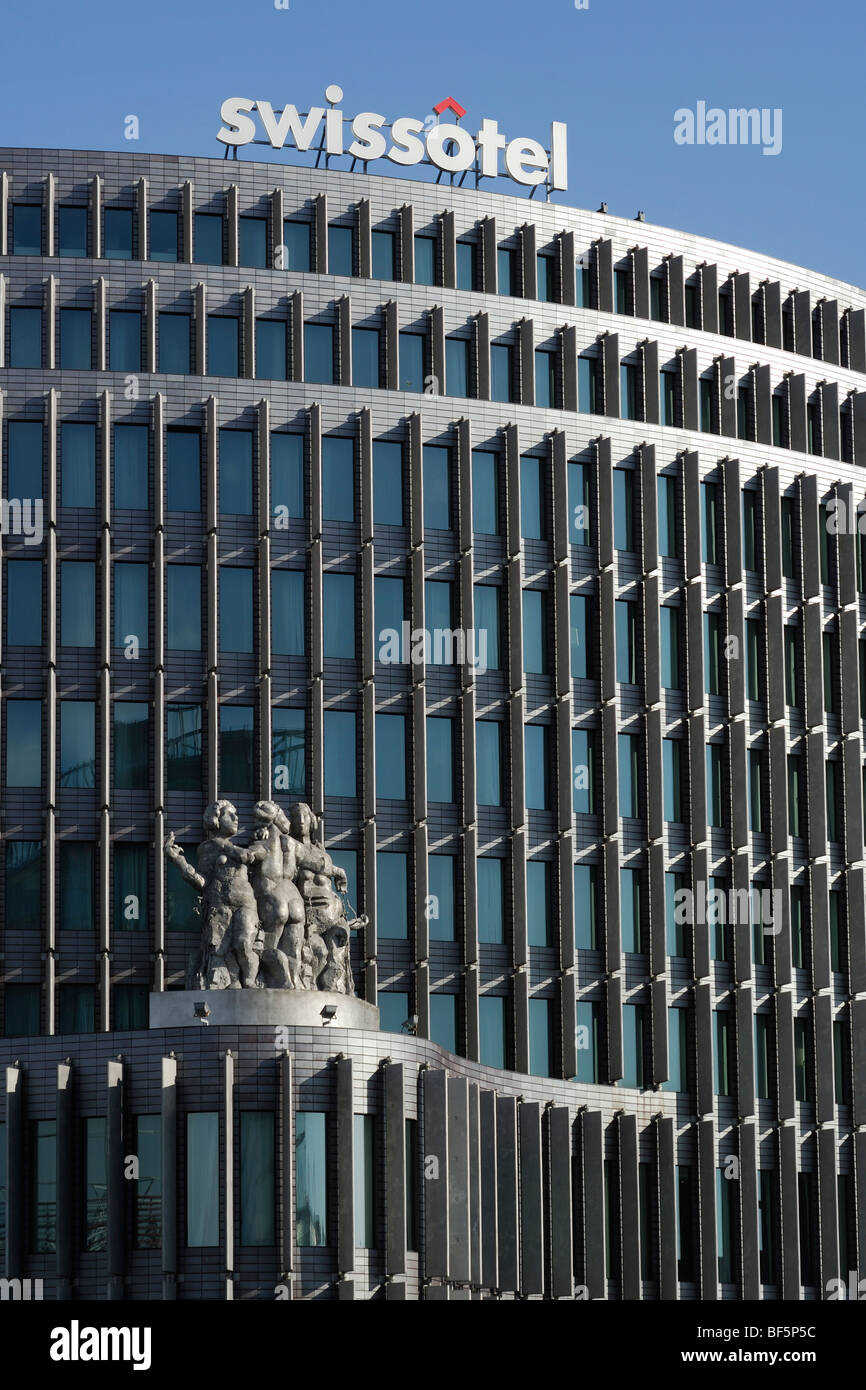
[0,0,866,286]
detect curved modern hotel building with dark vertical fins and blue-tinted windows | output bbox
[0,150,866,1300]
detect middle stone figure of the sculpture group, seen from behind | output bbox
[249,801,306,990]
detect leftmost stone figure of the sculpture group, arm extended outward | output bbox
[164,801,261,990]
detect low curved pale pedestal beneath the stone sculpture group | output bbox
[150,990,379,1033]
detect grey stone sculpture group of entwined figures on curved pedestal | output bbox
[164,801,367,994]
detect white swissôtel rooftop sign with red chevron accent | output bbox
[217,85,569,190]
